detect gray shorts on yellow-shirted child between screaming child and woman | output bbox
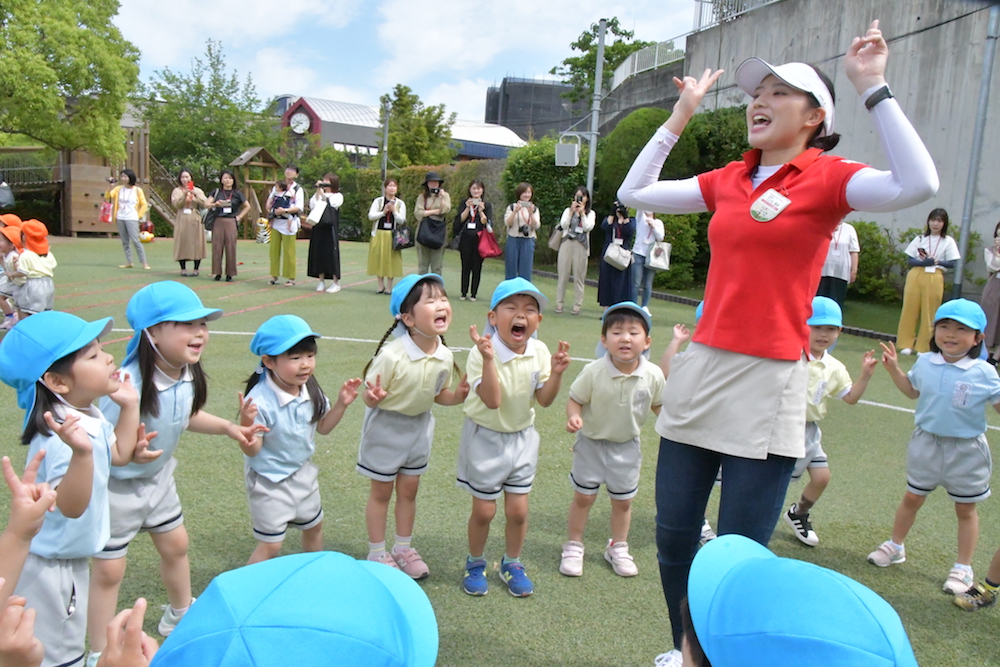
[569,433,642,500]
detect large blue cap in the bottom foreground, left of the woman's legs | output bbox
[151,551,438,667]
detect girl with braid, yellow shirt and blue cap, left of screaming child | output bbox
[357,273,469,579]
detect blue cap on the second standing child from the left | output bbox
[122,280,222,366]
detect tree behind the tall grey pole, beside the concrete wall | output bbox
[549,17,660,102]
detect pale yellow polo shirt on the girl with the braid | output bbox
[365,332,454,417]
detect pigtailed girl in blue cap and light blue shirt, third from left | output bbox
[240,315,361,563]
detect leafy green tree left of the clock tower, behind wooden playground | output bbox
[139,40,279,183]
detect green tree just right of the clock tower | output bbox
[377,83,458,167]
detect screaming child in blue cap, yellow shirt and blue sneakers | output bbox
[457,278,570,597]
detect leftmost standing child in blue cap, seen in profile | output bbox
[0,311,146,667]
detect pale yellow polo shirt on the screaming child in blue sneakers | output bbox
[465,336,552,433]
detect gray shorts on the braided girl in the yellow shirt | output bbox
[356,408,434,482]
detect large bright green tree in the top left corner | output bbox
[0,0,139,158]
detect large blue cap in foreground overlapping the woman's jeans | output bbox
[688,535,917,667]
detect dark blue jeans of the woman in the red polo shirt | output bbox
[656,438,795,649]
